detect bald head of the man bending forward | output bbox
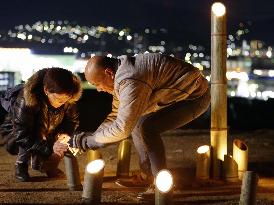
[85,56,118,93]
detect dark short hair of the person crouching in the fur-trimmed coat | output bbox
[43,68,78,95]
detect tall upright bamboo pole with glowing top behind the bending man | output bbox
[210,2,227,179]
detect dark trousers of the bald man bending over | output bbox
[132,89,210,177]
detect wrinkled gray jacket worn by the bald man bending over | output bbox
[84,54,208,148]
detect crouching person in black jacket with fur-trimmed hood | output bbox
[0,68,82,181]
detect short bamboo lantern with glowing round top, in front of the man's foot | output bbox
[155,169,173,205]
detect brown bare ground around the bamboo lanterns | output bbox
[0,130,274,204]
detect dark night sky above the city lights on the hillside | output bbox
[0,0,274,45]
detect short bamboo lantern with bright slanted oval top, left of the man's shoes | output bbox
[82,159,105,204]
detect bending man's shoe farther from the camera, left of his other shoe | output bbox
[115,174,153,188]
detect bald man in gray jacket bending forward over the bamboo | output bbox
[72,54,210,191]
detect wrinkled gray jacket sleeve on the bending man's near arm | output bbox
[85,79,152,147]
